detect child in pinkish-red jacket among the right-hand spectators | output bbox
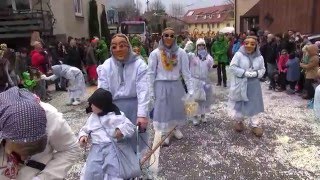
[277,49,289,91]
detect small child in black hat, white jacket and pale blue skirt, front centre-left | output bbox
[79,88,140,180]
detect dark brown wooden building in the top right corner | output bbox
[237,0,320,34]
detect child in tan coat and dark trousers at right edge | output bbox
[300,44,319,99]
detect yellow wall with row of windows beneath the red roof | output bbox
[187,19,235,34]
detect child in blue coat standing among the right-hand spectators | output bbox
[286,53,300,94]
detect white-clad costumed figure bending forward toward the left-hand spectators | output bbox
[41,64,86,106]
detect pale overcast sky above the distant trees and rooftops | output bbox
[136,0,225,12]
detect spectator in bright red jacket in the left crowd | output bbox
[30,41,47,74]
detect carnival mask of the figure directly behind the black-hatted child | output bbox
[111,36,129,61]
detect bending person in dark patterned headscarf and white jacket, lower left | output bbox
[0,87,80,180]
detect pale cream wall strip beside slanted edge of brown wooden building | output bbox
[235,0,259,33]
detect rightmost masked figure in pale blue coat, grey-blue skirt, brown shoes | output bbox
[229,36,265,137]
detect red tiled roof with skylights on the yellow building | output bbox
[183,4,234,24]
